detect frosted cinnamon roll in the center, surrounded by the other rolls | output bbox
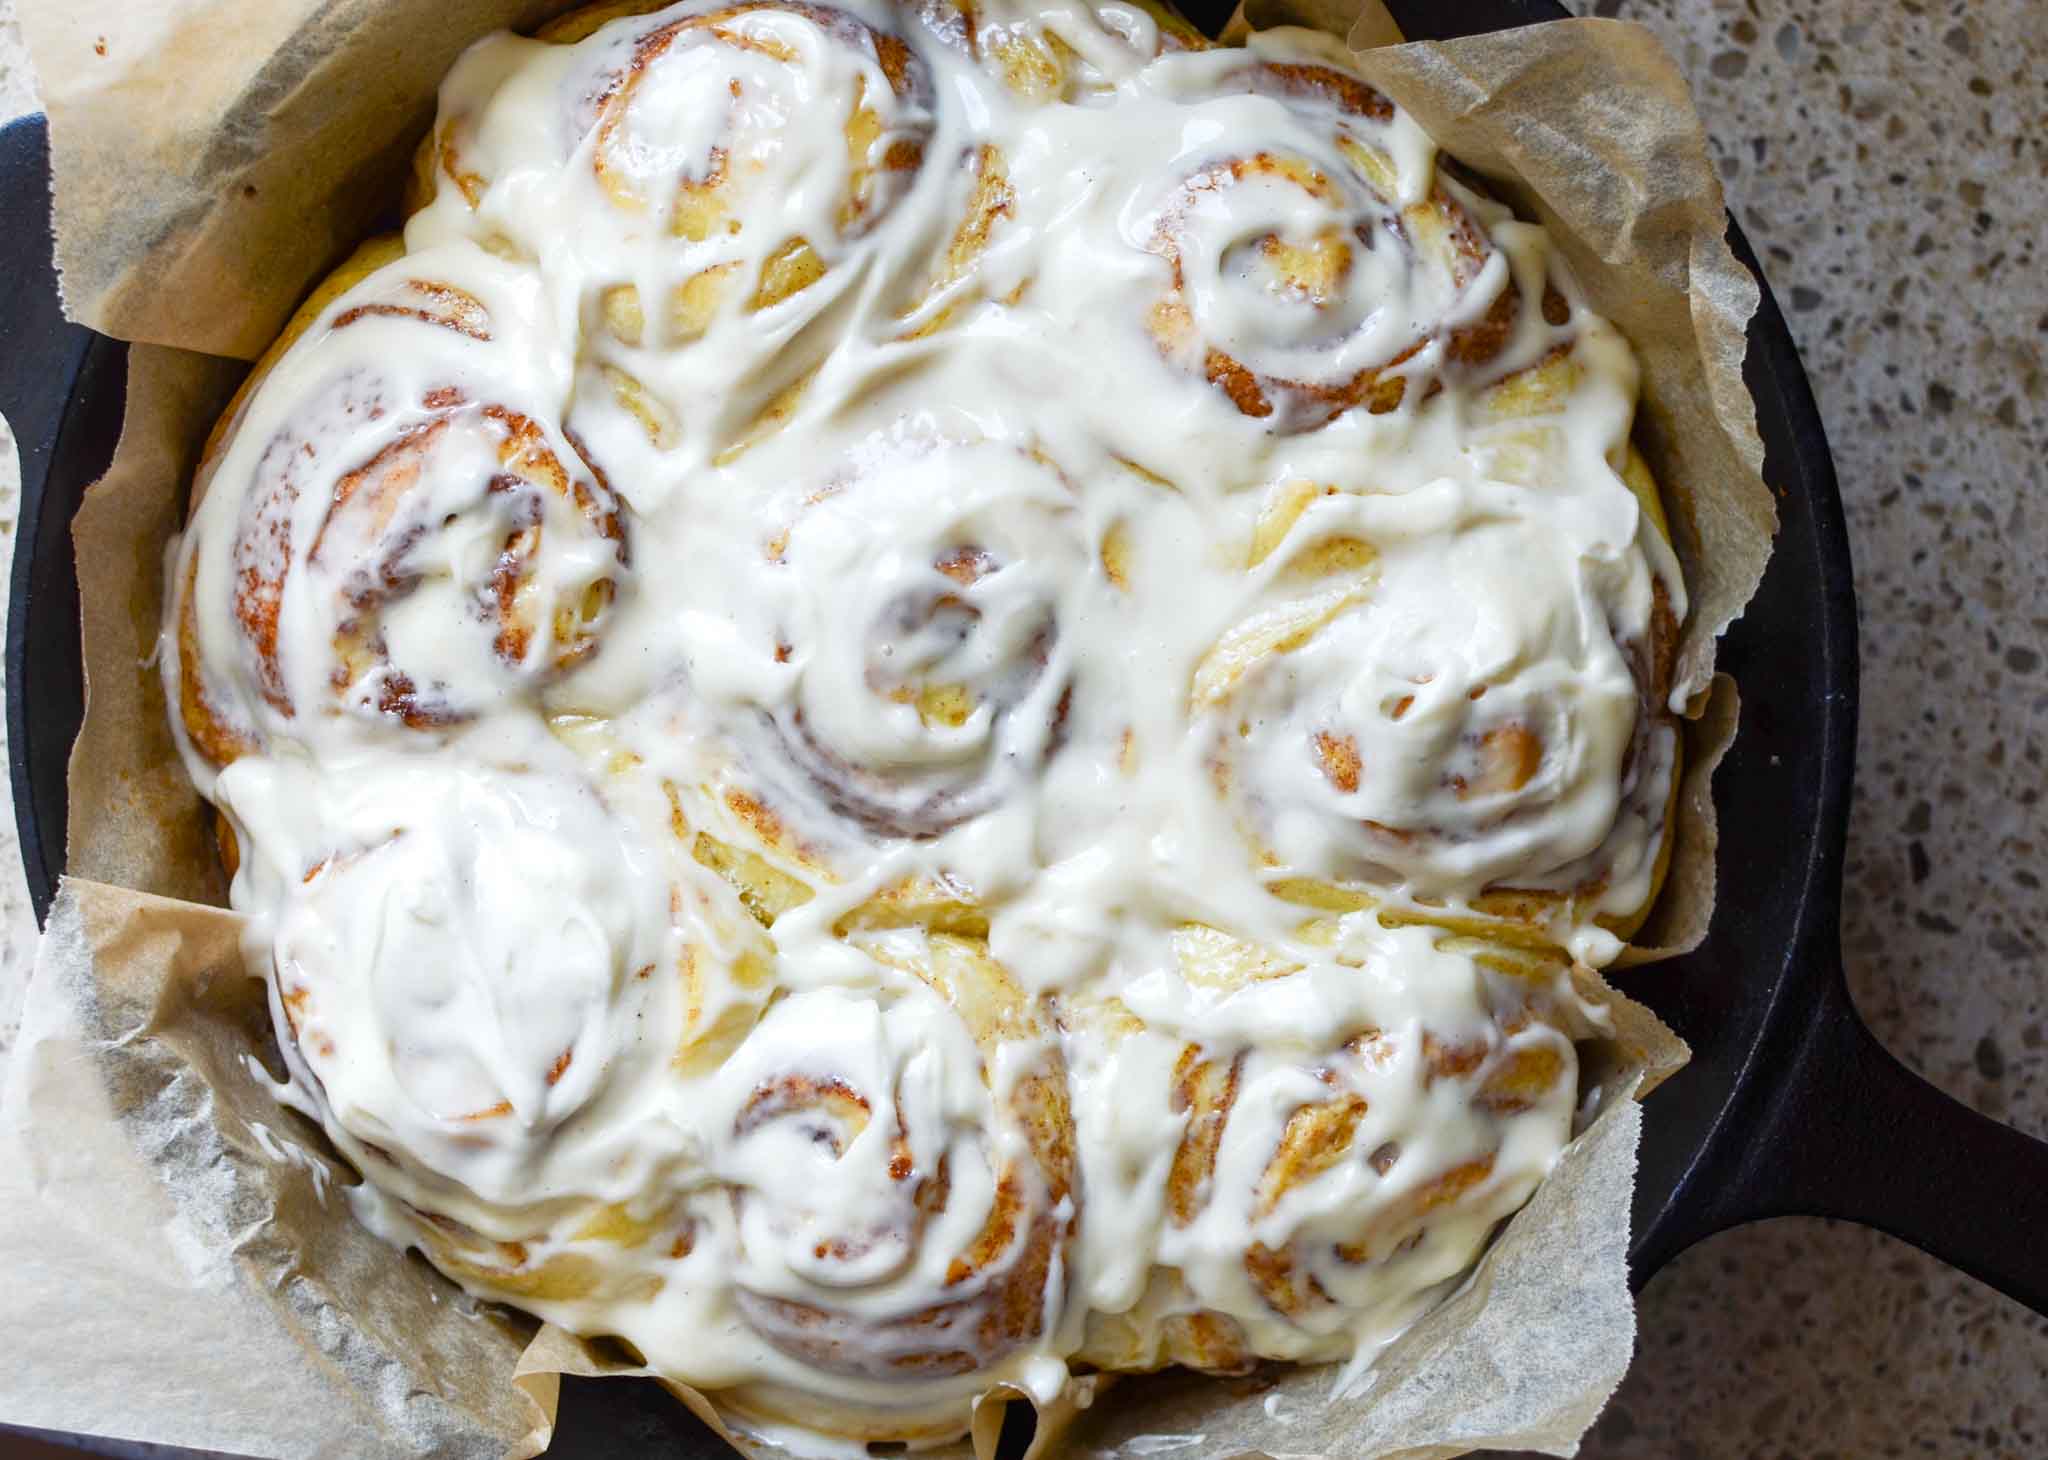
[712,432,1087,850]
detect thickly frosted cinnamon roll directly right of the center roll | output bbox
[1196,483,1655,897]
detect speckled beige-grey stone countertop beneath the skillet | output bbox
[0,0,2048,1460]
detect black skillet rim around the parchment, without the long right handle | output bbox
[0,0,1858,1448]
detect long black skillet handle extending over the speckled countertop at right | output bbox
[1710,971,2048,1315]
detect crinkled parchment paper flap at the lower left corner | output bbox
[0,876,559,1460]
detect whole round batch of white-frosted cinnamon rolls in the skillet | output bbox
[164,0,1686,1450]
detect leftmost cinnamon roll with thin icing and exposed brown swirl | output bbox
[168,241,629,766]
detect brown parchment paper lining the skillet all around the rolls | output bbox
[0,0,1774,1460]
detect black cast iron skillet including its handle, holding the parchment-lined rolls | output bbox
[0,0,2048,1456]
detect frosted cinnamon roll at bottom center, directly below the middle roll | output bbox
[709,932,1075,1437]
